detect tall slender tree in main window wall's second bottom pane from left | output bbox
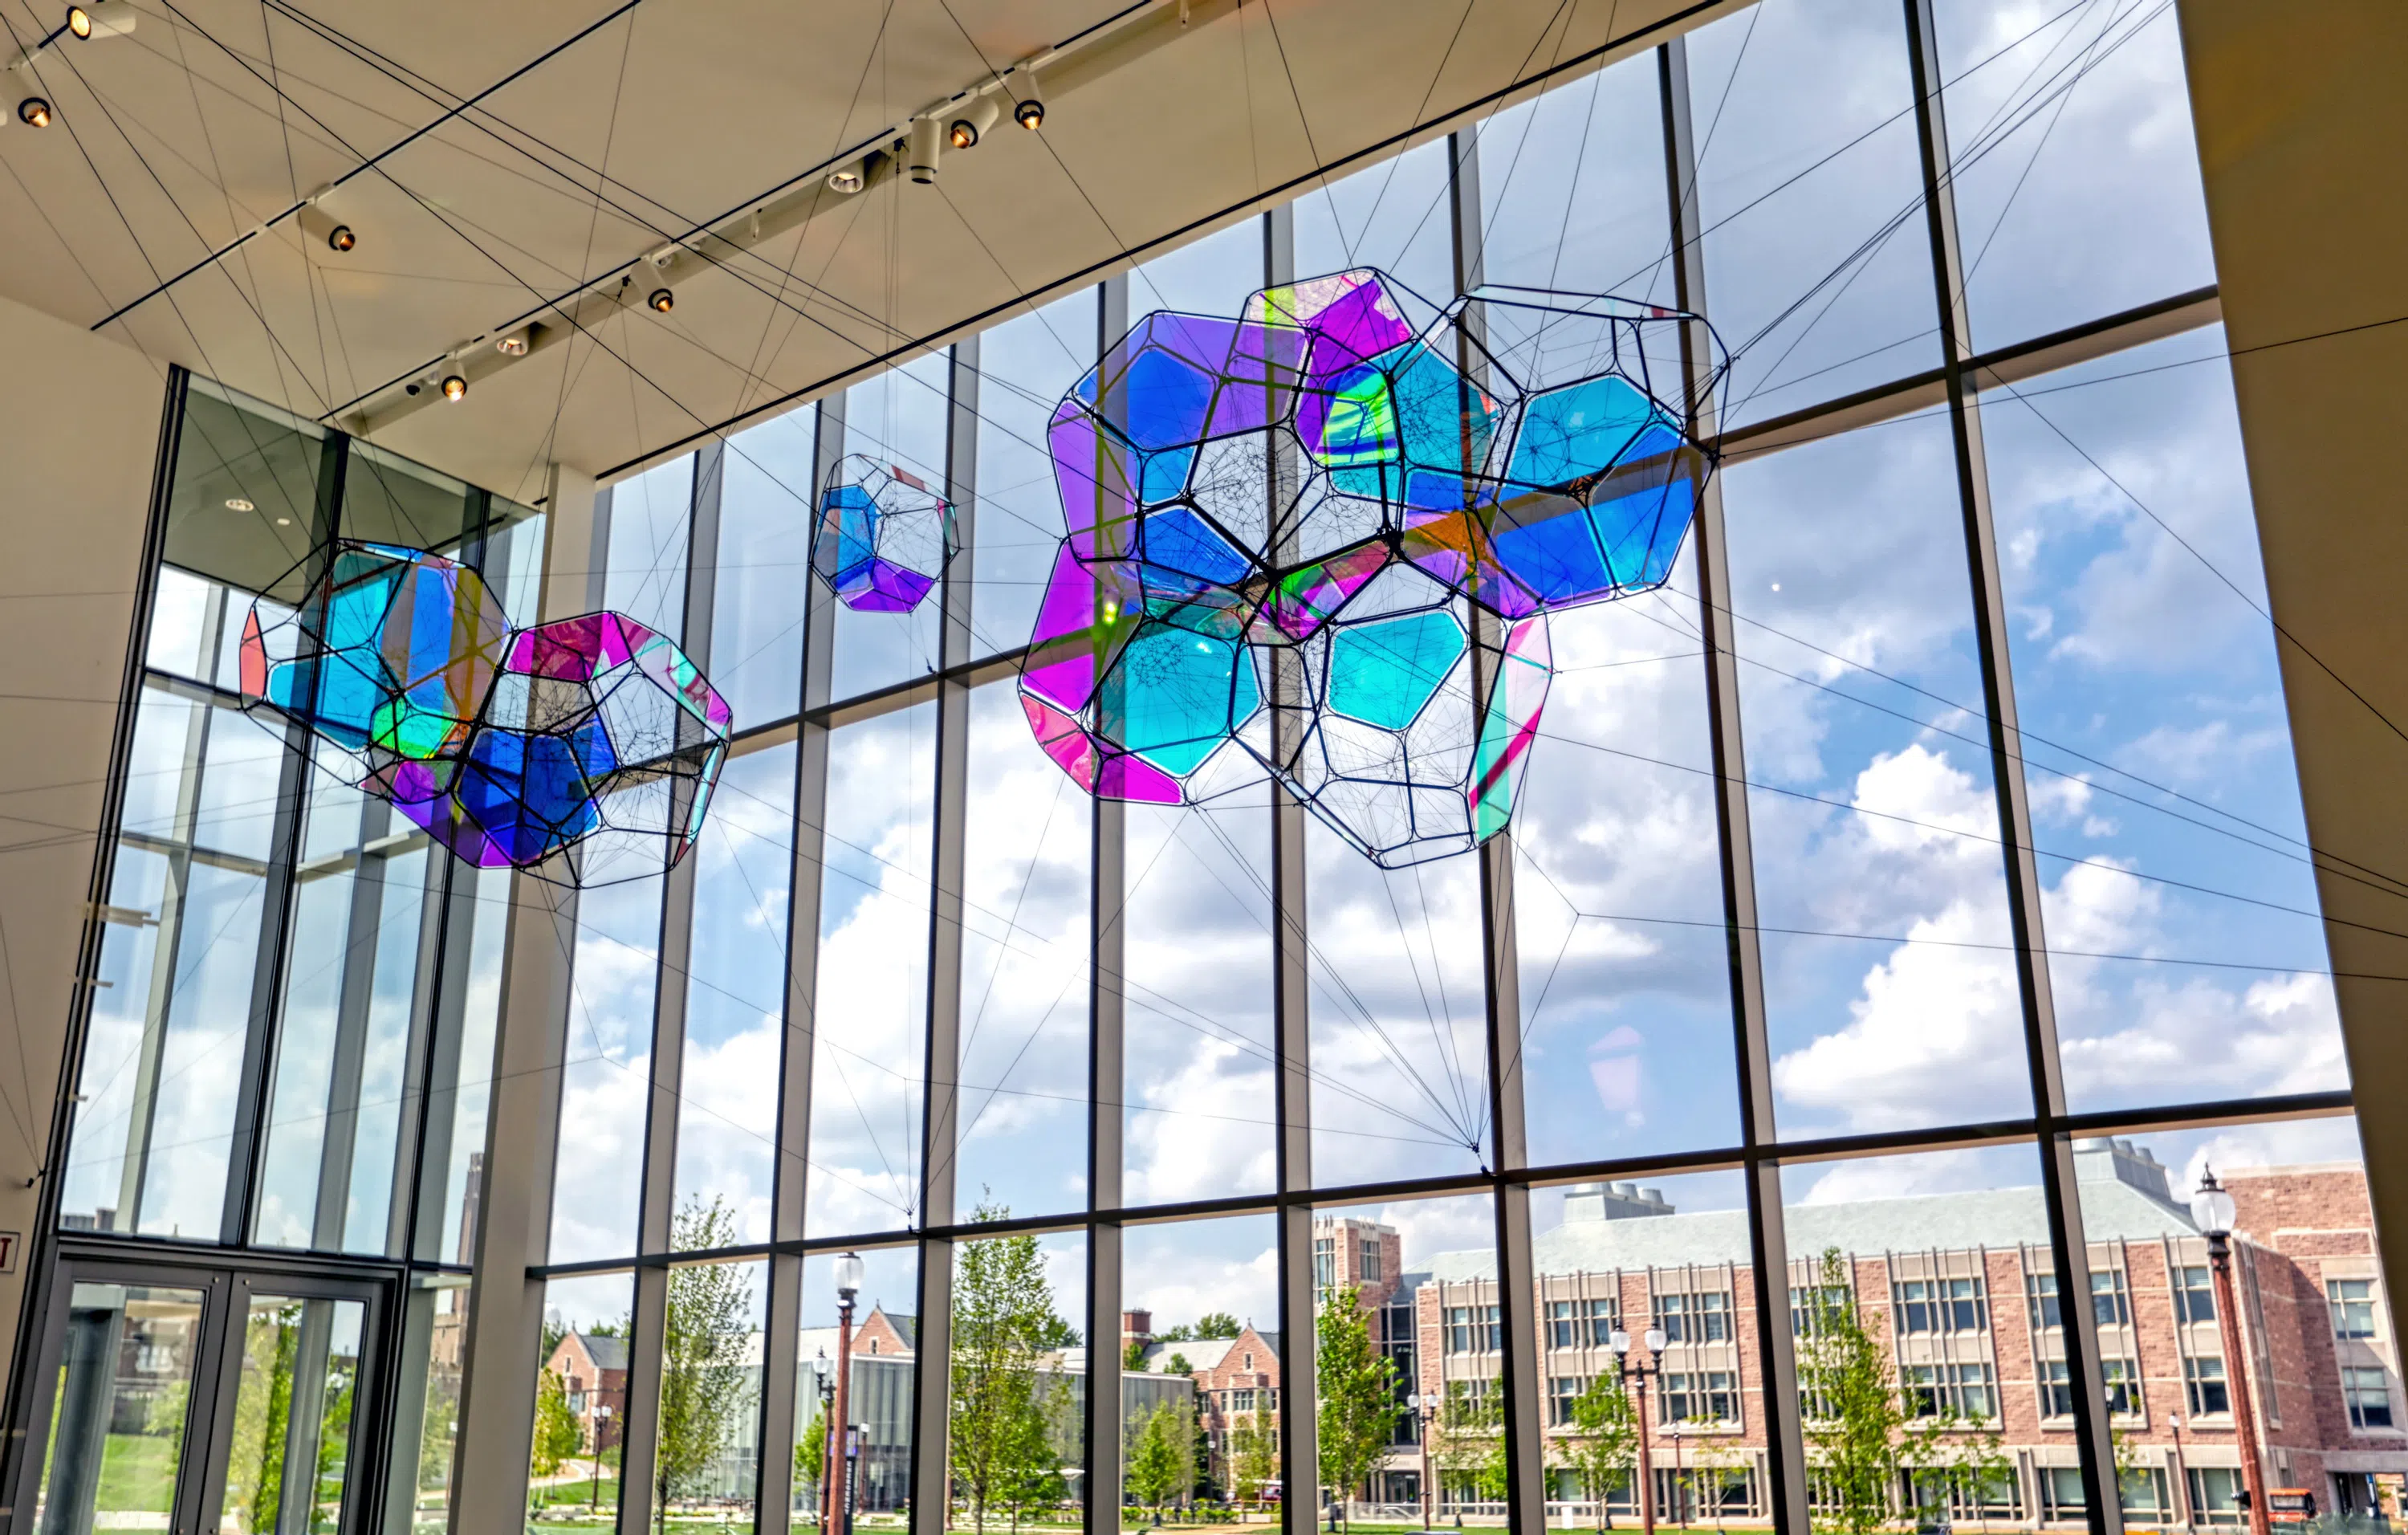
[653,1195,751,1530]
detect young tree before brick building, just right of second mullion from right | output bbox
[1796,1248,1905,1535]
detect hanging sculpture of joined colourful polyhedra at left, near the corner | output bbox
[241,539,732,887]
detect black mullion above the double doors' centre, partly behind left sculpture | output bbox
[224,431,352,1248]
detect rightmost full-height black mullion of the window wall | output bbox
[1905,0,2124,1535]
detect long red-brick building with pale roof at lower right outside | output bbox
[1397,1140,2408,1525]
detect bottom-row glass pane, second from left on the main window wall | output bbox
[653,1252,768,1530]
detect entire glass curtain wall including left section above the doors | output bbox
[33,0,2408,1535]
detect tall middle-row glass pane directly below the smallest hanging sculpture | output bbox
[804,703,937,1236]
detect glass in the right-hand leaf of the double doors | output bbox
[217,1294,368,1535]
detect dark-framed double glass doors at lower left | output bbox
[17,1260,383,1535]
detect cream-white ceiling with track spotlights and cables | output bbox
[0,0,1734,496]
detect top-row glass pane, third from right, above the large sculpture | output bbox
[1479,53,1674,306]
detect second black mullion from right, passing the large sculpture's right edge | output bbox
[1640,39,1811,1535]
